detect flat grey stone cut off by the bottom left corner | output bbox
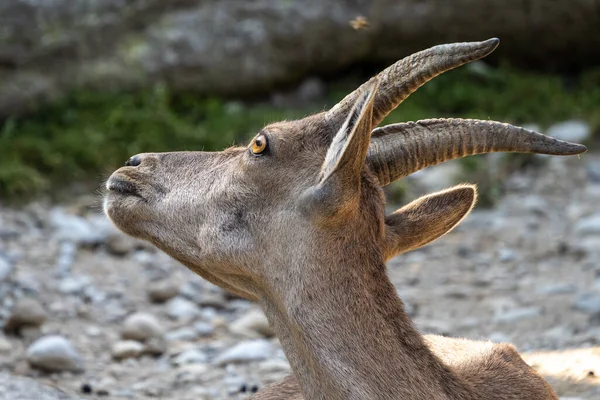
[0,372,81,400]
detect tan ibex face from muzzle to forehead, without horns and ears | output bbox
[105,114,370,298]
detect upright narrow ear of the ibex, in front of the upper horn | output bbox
[319,78,379,202]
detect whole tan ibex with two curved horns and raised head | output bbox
[104,39,586,400]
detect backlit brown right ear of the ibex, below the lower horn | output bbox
[384,185,477,260]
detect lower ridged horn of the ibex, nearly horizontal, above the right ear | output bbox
[367,118,587,186]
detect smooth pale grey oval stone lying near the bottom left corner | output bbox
[27,335,83,371]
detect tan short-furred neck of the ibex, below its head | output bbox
[263,256,469,400]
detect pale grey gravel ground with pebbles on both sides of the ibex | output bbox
[0,154,600,400]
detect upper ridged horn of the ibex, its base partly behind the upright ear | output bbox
[326,38,500,129]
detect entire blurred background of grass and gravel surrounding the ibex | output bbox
[0,0,600,400]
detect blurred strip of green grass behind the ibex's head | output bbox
[0,68,600,200]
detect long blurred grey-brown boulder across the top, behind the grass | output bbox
[0,0,600,117]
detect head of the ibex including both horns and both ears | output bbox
[105,39,586,299]
